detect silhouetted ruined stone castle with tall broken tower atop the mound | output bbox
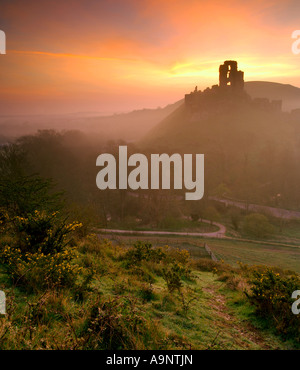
[185,60,282,115]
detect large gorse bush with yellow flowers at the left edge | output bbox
[0,210,81,290]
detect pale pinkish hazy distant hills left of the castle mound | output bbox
[0,100,182,144]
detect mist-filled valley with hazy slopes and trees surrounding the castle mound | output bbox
[0,77,300,241]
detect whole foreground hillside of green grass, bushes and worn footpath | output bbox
[0,230,300,350]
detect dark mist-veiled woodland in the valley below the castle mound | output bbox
[0,130,299,234]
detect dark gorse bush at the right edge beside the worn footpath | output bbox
[250,269,300,342]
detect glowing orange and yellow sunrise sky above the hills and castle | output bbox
[0,0,300,114]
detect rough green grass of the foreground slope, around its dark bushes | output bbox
[0,234,293,349]
